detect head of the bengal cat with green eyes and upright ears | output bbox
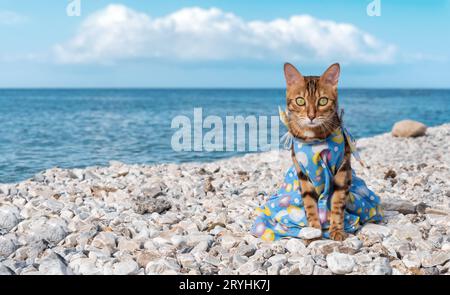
[284,63,340,140]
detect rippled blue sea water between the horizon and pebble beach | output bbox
[0,89,450,183]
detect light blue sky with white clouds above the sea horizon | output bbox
[0,0,450,88]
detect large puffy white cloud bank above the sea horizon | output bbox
[54,5,396,63]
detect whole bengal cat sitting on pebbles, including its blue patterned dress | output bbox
[251,63,383,243]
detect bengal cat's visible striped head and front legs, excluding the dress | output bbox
[284,63,352,241]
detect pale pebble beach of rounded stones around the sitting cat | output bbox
[0,124,450,275]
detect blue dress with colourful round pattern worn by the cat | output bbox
[251,128,383,241]
